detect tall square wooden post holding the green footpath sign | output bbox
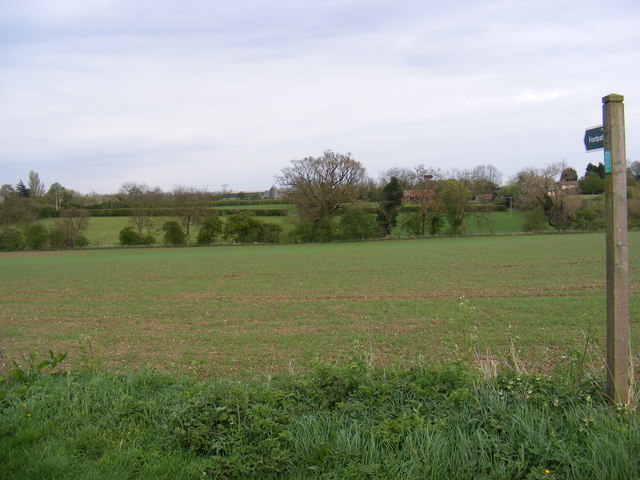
[602,94,632,404]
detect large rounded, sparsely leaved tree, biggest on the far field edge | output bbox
[276,150,368,237]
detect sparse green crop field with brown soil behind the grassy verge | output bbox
[0,232,640,378]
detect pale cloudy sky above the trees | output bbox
[0,0,640,193]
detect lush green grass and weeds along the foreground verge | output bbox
[0,360,640,480]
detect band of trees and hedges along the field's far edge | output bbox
[0,157,640,250]
